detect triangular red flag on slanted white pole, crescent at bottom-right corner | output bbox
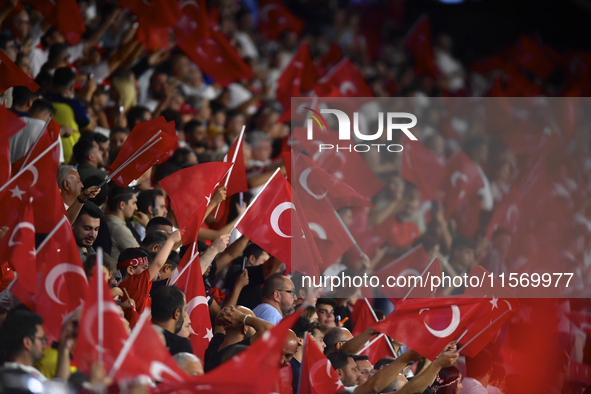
[107,308,191,382]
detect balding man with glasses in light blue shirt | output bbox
[253,273,297,325]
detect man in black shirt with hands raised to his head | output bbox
[204,306,274,372]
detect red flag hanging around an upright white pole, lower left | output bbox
[74,265,127,376]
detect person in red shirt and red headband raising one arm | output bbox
[117,231,181,313]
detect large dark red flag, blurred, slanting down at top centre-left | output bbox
[175,21,252,87]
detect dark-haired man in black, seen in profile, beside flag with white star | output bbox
[152,286,193,356]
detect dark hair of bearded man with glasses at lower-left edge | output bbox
[1,305,43,360]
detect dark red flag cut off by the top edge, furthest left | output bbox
[28,0,86,45]
